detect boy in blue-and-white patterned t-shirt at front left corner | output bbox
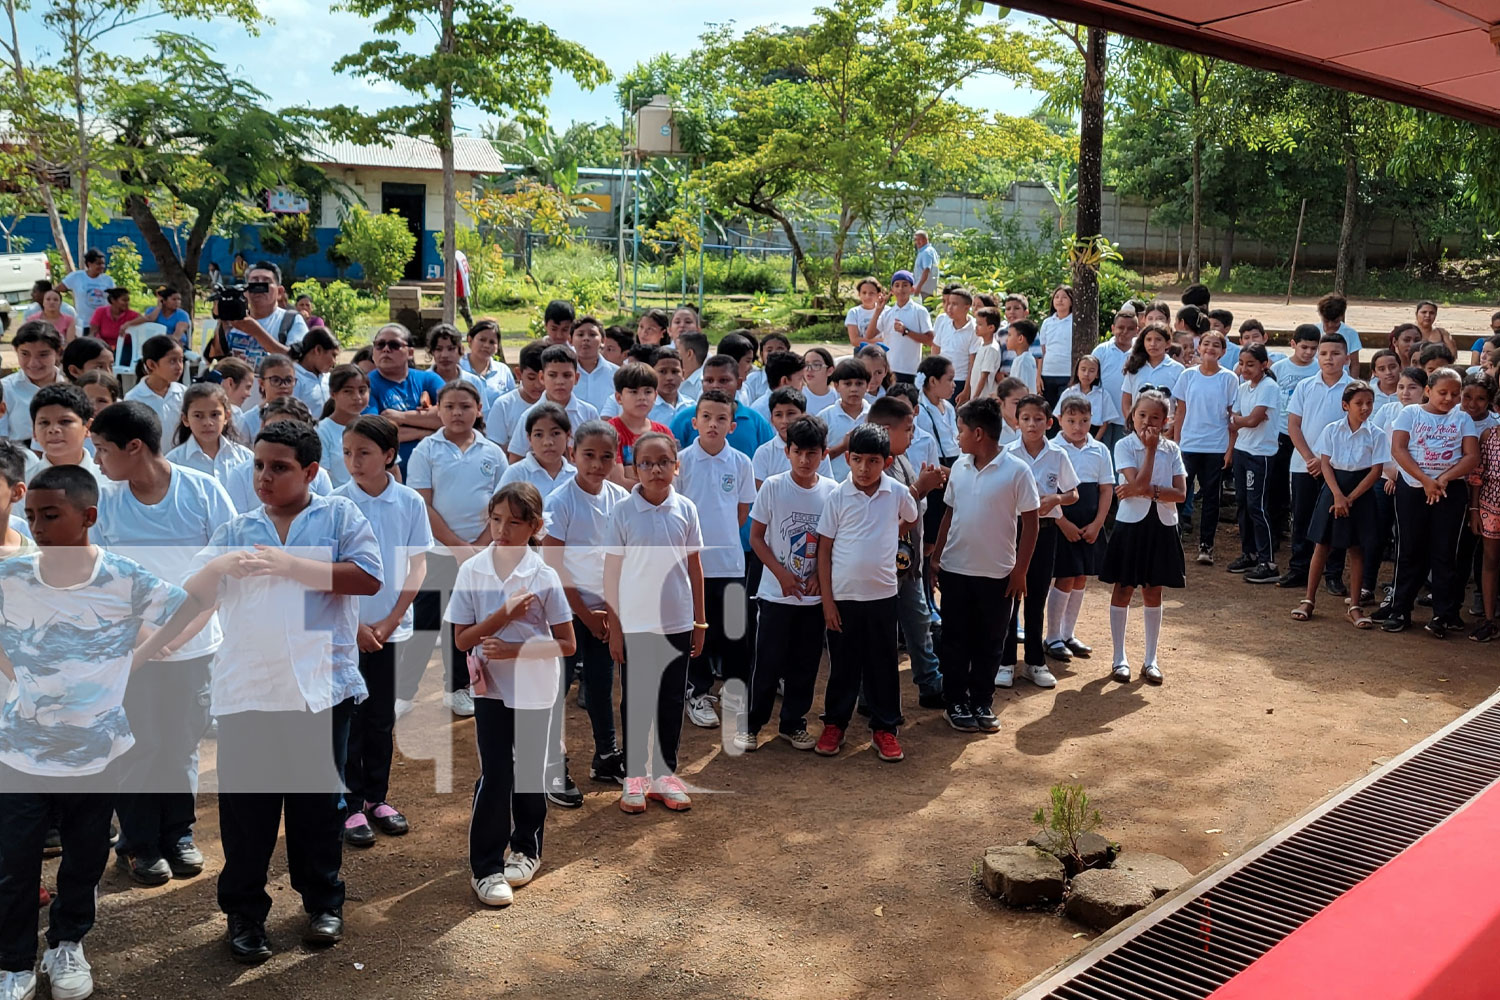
[0,466,213,997]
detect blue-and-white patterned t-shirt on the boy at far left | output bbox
[0,547,188,778]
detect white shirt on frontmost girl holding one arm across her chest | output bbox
[443,546,573,709]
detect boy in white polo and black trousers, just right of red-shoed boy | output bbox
[932,397,1038,733]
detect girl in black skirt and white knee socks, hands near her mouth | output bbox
[1100,390,1188,684]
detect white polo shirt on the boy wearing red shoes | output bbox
[818,475,920,601]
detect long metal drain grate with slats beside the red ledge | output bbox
[1016,694,1500,1000]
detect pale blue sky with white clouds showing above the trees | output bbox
[11,0,1038,132]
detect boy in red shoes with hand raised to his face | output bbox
[815,424,920,762]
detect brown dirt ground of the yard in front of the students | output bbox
[47,515,1500,1000]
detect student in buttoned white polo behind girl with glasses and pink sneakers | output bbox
[675,388,755,729]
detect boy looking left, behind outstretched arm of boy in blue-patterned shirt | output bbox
[90,402,234,886]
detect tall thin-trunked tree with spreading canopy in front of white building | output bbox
[327,0,609,322]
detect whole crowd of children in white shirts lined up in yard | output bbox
[0,271,1500,1000]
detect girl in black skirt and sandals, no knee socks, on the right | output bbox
[1292,379,1383,628]
